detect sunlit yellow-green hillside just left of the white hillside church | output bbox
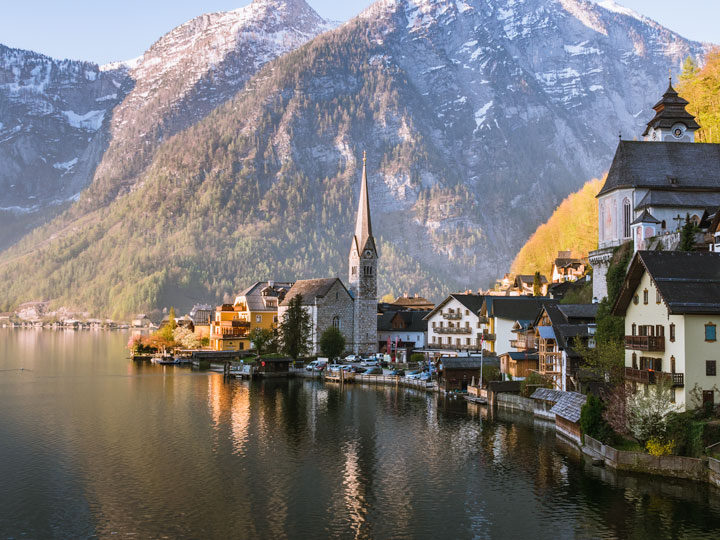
[512,179,605,276]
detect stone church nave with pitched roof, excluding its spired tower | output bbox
[278,278,352,355]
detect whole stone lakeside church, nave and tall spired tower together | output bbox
[278,153,379,355]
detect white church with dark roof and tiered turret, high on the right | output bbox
[589,81,720,299]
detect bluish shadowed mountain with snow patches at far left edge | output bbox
[0,45,130,249]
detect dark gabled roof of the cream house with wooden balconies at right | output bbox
[613,251,720,316]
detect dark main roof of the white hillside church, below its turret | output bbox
[597,141,720,197]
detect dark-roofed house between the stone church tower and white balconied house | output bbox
[378,310,430,359]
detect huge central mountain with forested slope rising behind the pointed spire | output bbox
[0,0,706,316]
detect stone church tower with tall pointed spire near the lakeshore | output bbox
[348,152,378,354]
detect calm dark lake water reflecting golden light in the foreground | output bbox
[0,329,720,540]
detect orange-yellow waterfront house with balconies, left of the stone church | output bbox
[210,281,292,351]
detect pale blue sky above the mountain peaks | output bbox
[0,0,720,64]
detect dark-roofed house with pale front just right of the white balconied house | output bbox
[478,296,556,355]
